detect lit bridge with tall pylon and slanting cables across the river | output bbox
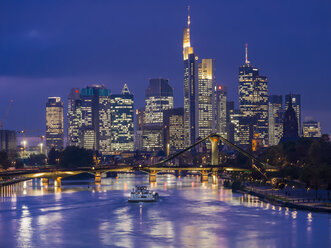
[0,134,275,187]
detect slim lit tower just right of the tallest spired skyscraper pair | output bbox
[213,85,228,139]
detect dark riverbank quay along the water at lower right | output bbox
[240,186,331,213]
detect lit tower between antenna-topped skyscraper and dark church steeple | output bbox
[268,95,284,146]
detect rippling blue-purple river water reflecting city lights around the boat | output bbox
[0,175,331,248]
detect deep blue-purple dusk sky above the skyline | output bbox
[0,0,331,135]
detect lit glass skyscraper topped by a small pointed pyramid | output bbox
[111,84,134,152]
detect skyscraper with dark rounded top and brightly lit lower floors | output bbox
[145,78,174,125]
